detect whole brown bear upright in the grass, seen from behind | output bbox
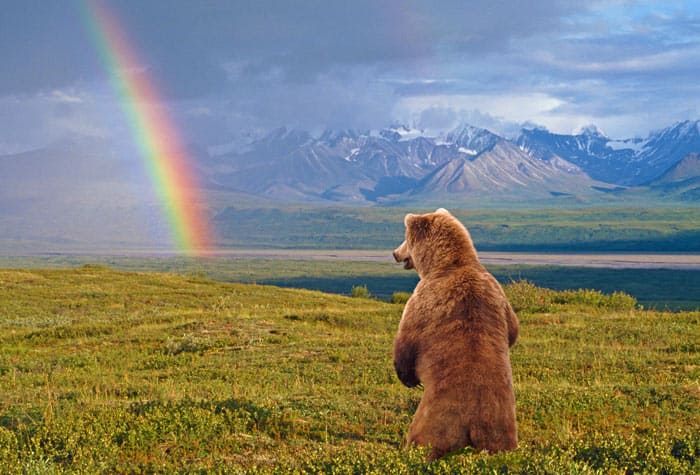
[394,208,519,460]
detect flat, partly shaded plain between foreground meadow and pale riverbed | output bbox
[0,251,700,310]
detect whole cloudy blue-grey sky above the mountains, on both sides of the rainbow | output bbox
[0,0,700,154]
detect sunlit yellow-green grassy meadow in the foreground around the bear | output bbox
[0,266,700,474]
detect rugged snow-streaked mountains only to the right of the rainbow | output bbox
[201,121,700,204]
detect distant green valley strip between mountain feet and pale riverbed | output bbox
[216,207,700,252]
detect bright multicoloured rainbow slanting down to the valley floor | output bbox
[83,0,213,255]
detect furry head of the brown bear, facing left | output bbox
[393,208,478,277]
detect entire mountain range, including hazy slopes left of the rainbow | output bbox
[0,121,700,249]
